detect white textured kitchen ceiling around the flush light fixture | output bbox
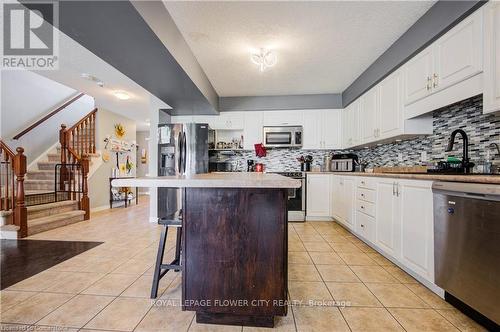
[164,1,434,96]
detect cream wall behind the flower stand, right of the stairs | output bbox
[89,109,137,209]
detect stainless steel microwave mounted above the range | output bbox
[263,126,302,148]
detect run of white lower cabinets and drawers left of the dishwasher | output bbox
[328,174,434,283]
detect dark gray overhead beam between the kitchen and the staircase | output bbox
[59,1,218,115]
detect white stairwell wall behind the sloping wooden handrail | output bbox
[0,70,95,163]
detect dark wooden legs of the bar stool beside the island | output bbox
[151,224,186,299]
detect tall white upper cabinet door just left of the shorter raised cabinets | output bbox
[378,71,404,139]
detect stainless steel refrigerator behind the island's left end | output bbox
[158,123,208,218]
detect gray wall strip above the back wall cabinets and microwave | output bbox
[219,94,342,112]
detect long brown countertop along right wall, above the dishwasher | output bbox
[308,172,500,184]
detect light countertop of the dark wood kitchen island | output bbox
[111,172,301,188]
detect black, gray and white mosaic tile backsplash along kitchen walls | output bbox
[221,95,500,172]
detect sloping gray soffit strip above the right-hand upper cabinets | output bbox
[342,0,487,107]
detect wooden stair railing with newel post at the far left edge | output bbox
[0,140,28,237]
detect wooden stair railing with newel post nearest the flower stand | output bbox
[56,108,97,220]
